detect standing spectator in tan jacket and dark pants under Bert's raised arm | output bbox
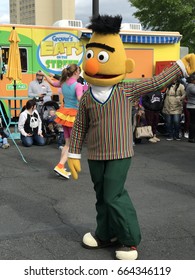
[163,80,186,141]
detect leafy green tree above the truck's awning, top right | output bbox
[128,0,195,52]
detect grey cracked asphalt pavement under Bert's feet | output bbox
[0,136,195,260]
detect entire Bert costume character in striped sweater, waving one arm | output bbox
[68,15,195,260]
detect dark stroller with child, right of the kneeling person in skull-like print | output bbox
[39,101,63,144]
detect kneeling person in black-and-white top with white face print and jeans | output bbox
[18,99,46,147]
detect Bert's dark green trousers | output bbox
[88,158,141,246]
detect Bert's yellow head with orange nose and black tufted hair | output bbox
[83,15,134,86]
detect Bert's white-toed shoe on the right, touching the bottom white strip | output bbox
[115,246,138,260]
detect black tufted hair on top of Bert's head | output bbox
[88,15,122,34]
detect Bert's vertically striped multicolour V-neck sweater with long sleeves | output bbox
[69,64,182,160]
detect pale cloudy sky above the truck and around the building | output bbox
[0,0,138,25]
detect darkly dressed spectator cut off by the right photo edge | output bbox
[186,73,195,143]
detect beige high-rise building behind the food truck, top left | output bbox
[10,0,75,26]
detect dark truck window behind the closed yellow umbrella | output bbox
[1,47,28,73]
